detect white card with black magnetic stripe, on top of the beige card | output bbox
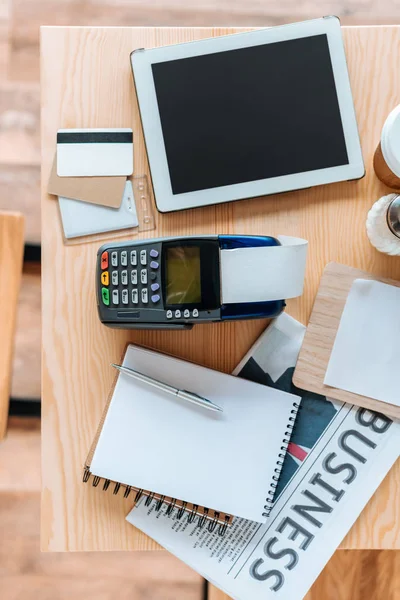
[57,128,133,177]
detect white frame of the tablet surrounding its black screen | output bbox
[131,17,365,212]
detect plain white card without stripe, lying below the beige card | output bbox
[58,181,139,239]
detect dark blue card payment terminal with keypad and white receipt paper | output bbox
[96,235,307,329]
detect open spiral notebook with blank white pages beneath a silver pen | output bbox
[84,345,300,527]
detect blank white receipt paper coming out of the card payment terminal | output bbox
[220,235,308,304]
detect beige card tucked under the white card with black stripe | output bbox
[47,155,126,208]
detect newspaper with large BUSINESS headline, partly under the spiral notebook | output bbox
[127,314,400,600]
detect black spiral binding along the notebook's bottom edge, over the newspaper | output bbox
[82,467,232,536]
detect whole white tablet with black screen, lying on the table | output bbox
[131,17,364,212]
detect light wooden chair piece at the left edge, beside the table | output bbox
[0,212,24,440]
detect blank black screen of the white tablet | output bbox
[152,35,349,194]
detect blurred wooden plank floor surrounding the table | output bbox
[0,0,400,600]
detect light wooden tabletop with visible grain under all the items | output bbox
[41,27,400,551]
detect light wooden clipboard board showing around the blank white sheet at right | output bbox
[293,262,400,418]
